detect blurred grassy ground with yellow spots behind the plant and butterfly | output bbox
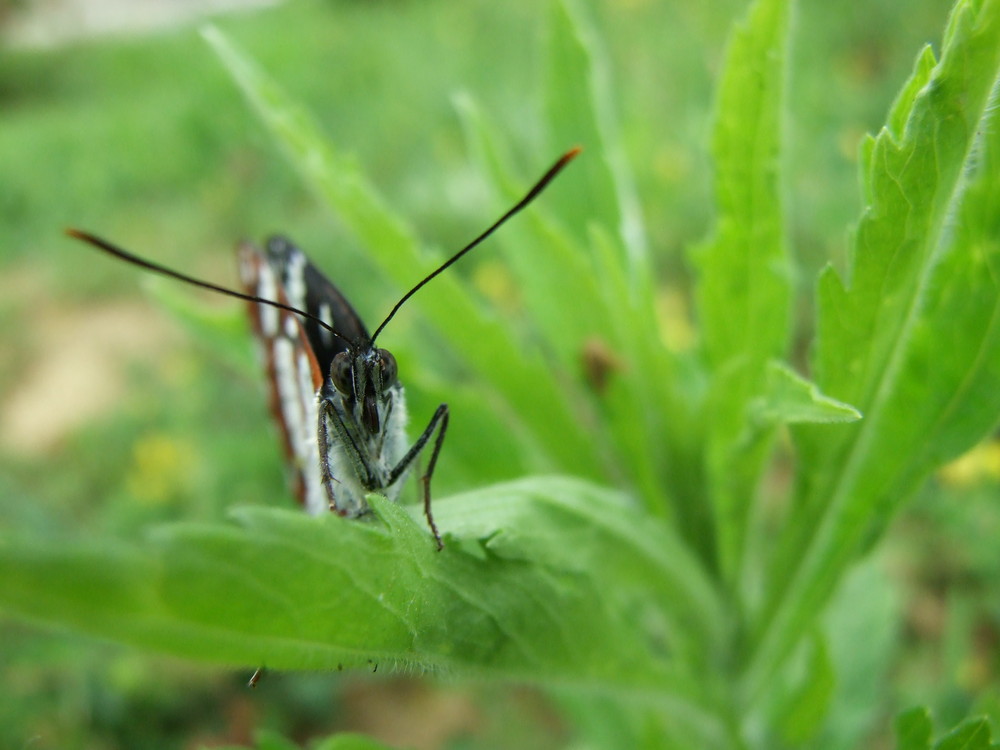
[0,0,1000,748]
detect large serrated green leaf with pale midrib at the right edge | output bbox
[749,0,1000,704]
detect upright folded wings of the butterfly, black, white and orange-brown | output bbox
[239,237,368,514]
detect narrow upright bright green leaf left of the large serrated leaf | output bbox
[694,0,791,584]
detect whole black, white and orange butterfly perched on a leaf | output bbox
[66,148,580,549]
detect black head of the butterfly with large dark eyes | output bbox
[330,346,398,435]
